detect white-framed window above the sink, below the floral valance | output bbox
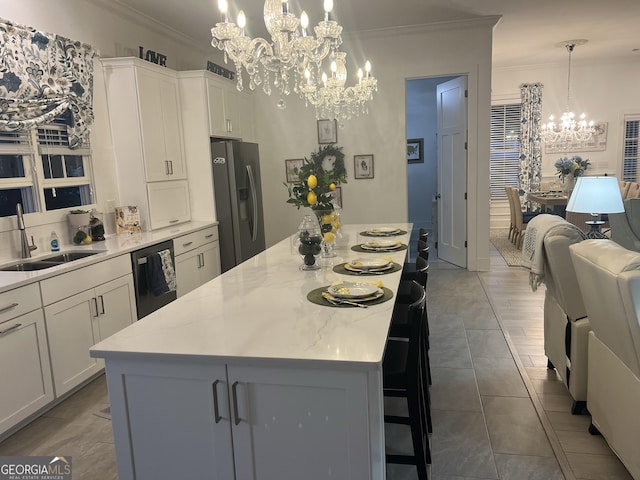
[0,122,95,217]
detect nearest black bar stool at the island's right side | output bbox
[382,282,431,480]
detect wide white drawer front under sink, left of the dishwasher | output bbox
[40,255,131,305]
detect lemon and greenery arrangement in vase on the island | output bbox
[284,145,347,256]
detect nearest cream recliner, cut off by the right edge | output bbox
[569,240,640,480]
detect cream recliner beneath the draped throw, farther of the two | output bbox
[543,221,590,414]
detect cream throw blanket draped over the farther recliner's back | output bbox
[521,214,584,292]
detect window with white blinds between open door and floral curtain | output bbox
[489,103,521,199]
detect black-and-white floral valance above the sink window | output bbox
[0,18,96,148]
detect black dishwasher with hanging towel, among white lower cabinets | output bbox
[131,240,176,320]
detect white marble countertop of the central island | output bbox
[91,223,412,370]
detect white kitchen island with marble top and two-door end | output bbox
[91,223,412,480]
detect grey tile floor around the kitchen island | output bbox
[0,238,631,480]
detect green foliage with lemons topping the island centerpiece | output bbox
[284,145,347,210]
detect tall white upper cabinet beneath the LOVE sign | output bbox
[102,58,191,230]
